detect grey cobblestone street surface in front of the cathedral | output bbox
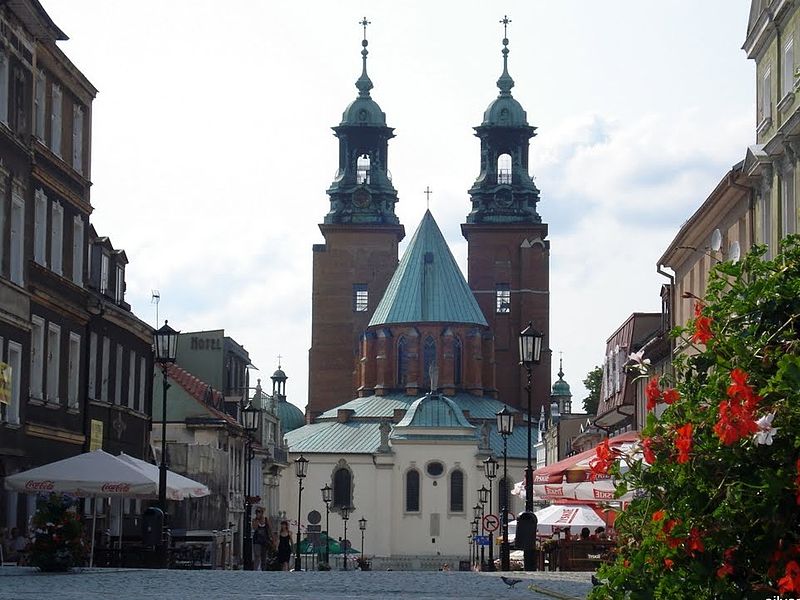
[0,567,591,600]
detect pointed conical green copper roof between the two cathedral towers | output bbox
[369,211,486,327]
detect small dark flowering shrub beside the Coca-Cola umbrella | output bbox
[30,494,86,571]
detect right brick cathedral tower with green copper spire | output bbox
[461,18,551,414]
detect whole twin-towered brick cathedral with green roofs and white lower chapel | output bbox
[280,19,551,568]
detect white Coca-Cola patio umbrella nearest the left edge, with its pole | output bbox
[4,450,158,567]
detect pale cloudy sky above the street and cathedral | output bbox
[41,0,756,408]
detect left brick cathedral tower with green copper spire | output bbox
[307,18,405,418]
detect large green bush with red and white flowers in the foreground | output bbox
[590,236,800,600]
